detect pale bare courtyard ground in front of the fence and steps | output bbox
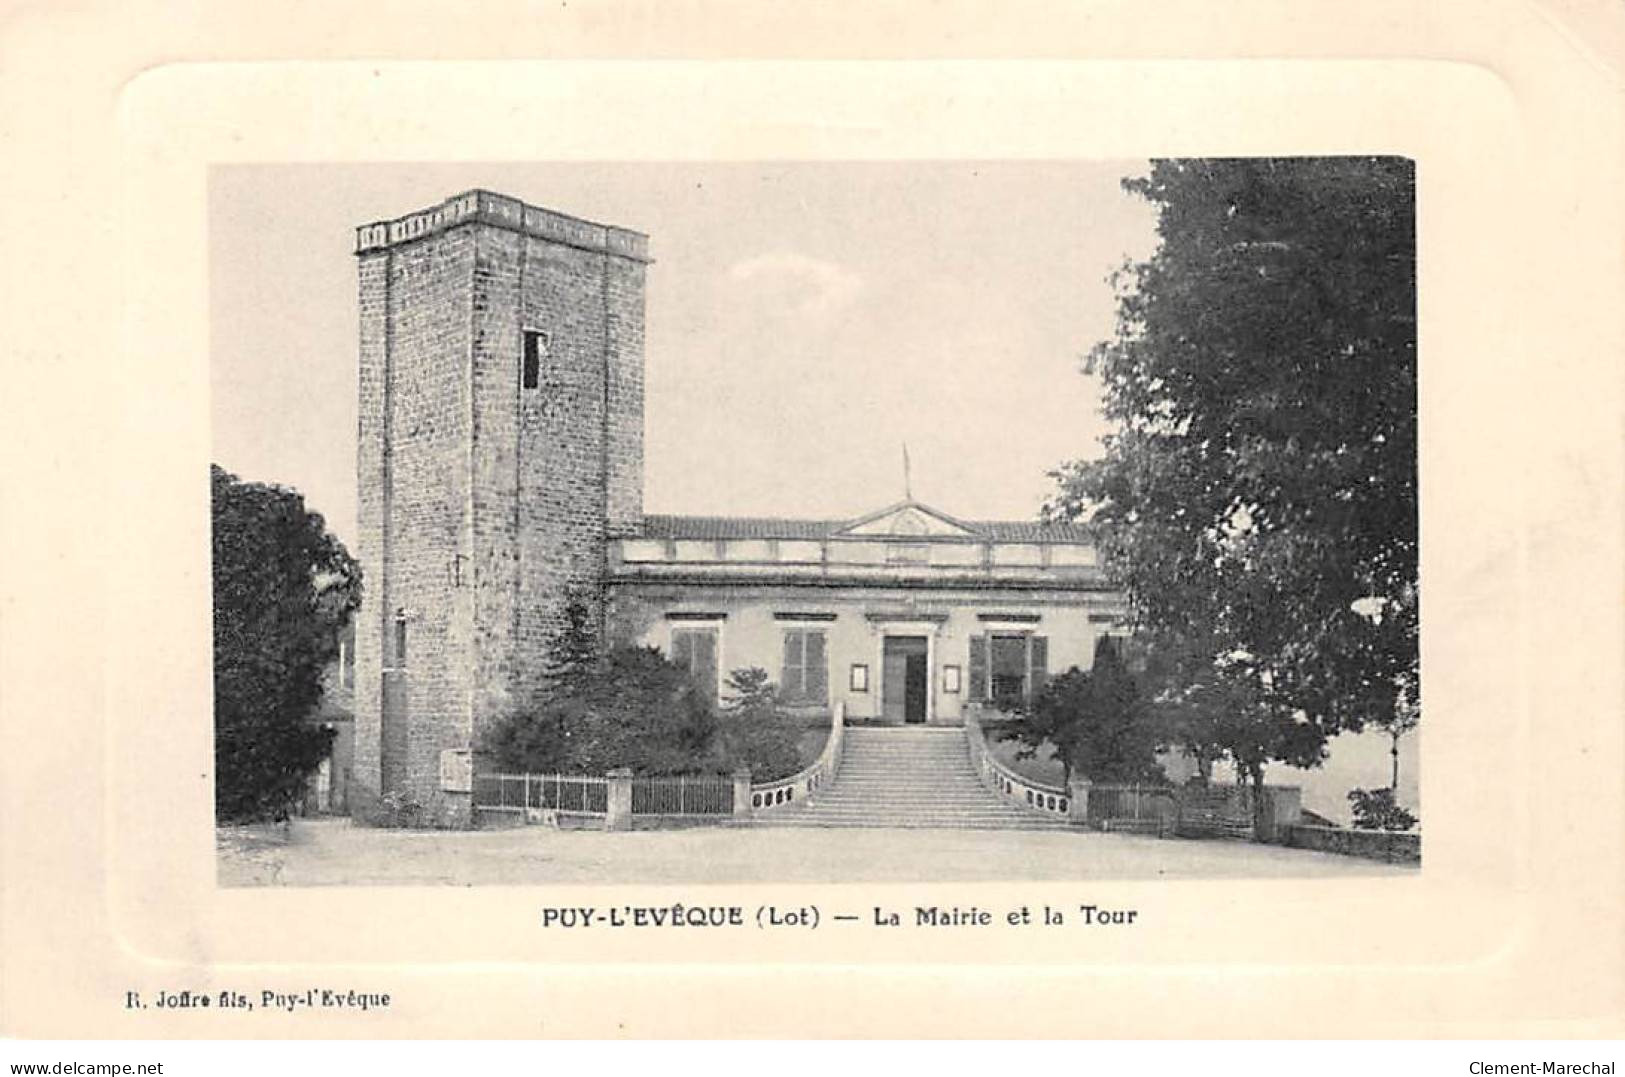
[218,819,1415,887]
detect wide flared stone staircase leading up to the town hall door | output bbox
[752,726,1068,830]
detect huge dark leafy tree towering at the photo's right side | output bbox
[1048,158,1419,792]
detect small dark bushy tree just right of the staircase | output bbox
[999,637,1164,781]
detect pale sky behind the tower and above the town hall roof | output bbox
[208,161,1155,547]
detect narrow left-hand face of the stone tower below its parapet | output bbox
[356,222,475,824]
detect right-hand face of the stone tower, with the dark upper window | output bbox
[475,226,644,741]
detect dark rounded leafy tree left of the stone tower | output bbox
[210,465,361,820]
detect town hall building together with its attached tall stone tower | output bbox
[351,190,1123,825]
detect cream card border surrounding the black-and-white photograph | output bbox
[0,3,1625,1036]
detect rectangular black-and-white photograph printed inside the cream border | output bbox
[210,156,1422,885]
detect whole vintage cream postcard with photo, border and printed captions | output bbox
[0,0,1625,1038]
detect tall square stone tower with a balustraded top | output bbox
[353,190,648,825]
